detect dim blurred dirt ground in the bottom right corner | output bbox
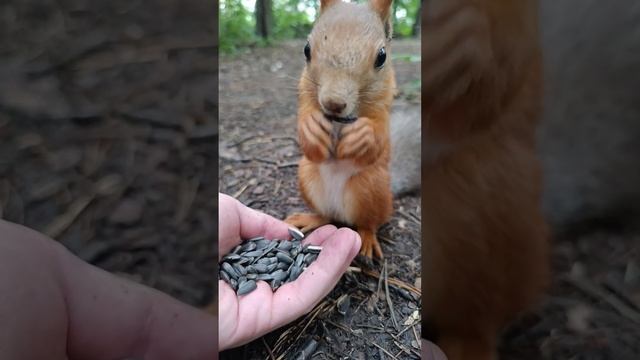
[501,226,640,360]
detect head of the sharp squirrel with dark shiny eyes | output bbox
[300,0,393,122]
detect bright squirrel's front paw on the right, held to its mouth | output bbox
[336,117,382,165]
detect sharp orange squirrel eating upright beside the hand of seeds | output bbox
[285,0,396,258]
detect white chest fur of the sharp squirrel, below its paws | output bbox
[317,160,360,222]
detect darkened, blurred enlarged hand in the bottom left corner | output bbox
[0,220,218,360]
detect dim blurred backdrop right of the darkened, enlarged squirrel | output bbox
[501,0,640,360]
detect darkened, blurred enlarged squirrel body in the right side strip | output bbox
[422,0,549,360]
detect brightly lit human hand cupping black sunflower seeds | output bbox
[218,194,360,350]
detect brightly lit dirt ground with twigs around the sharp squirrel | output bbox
[220,40,421,359]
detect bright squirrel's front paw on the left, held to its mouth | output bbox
[298,111,332,162]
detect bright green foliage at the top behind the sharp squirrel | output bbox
[219,0,420,52]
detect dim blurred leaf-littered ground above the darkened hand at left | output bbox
[0,0,218,306]
